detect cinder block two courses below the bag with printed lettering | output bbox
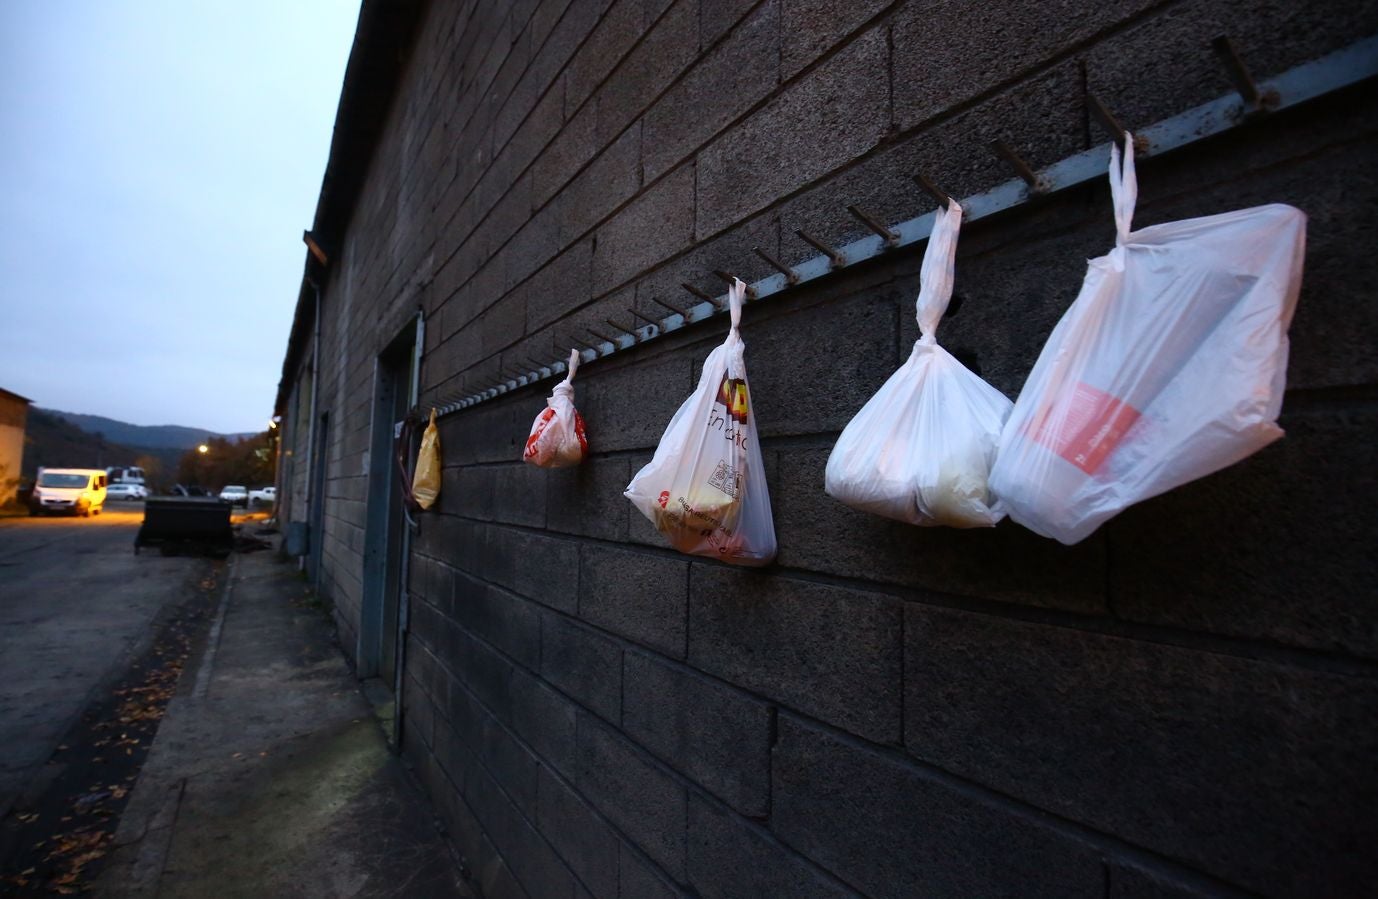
[621,652,772,818]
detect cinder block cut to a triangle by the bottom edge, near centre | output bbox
[689,794,856,899]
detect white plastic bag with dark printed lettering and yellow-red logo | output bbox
[624,280,776,565]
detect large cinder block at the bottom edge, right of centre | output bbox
[770,714,1105,898]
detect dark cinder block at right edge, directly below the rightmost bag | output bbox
[1107,400,1378,658]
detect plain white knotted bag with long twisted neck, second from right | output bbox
[824,201,1013,528]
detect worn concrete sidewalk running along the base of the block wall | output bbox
[98,552,470,899]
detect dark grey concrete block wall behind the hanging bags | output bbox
[298,0,1378,898]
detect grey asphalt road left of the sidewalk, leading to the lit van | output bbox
[0,502,212,815]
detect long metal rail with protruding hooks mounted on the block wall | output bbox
[435,36,1378,415]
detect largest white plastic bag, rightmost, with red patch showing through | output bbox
[991,135,1306,545]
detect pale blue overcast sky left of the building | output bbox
[0,0,358,432]
